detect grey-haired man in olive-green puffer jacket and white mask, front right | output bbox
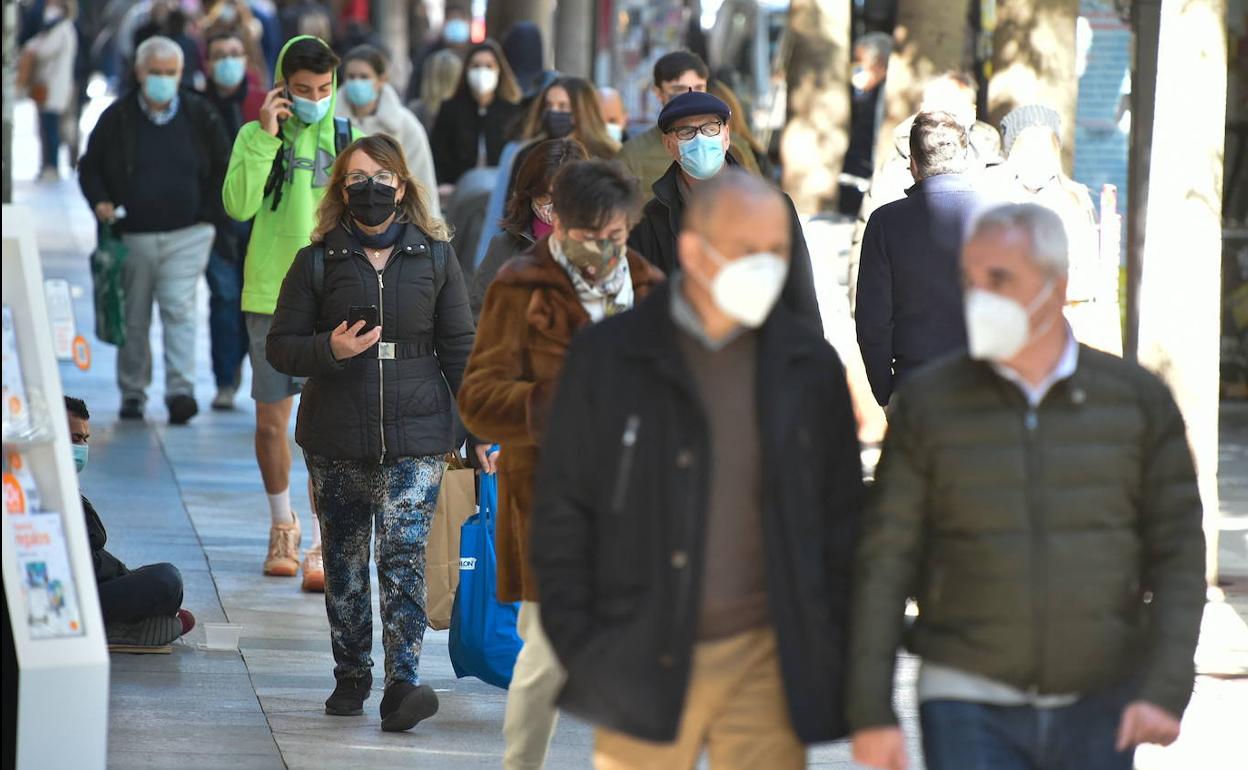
[847,203,1204,770]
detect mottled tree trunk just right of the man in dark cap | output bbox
[780,0,850,215]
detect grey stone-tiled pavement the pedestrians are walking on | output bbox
[14,97,1248,770]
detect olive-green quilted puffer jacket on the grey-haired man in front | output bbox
[843,347,1204,730]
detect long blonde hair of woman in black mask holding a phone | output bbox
[312,134,451,243]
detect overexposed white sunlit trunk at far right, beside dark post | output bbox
[1138,0,1227,580]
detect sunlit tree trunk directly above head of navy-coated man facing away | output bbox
[875,0,970,178]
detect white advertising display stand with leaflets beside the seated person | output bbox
[2,206,109,770]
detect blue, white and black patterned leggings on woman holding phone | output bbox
[306,454,444,686]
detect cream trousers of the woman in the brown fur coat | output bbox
[503,602,567,770]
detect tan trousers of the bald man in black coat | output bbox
[594,626,806,770]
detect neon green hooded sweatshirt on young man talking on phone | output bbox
[221,35,361,316]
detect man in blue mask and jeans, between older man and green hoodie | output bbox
[203,29,265,411]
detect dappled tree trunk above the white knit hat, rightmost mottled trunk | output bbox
[988,0,1080,173]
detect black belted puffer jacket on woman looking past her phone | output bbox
[266,225,473,462]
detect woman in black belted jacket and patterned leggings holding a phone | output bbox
[267,134,473,731]
